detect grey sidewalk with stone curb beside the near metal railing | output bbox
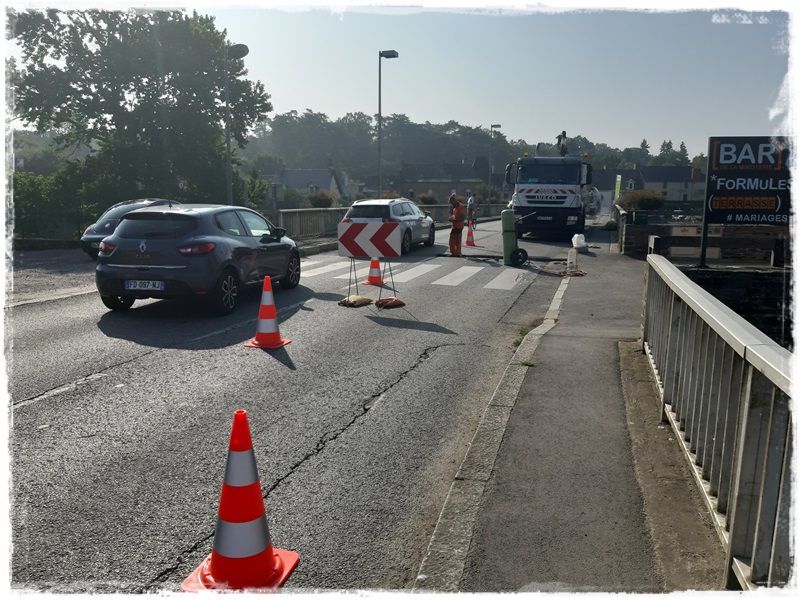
[416,234,724,592]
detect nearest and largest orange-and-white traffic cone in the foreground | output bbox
[181,410,300,592]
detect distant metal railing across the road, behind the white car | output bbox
[278,204,506,239]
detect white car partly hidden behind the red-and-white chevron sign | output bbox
[342,198,436,254]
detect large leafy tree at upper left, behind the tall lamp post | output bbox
[12,10,272,201]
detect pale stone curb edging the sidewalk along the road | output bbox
[412,276,570,592]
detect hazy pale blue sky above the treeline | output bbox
[197,4,790,156]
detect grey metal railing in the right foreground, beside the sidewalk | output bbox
[643,254,793,590]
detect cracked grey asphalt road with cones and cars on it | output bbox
[6,222,569,592]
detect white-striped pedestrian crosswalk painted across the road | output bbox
[301,257,535,290]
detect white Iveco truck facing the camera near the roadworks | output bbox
[505,155,593,238]
